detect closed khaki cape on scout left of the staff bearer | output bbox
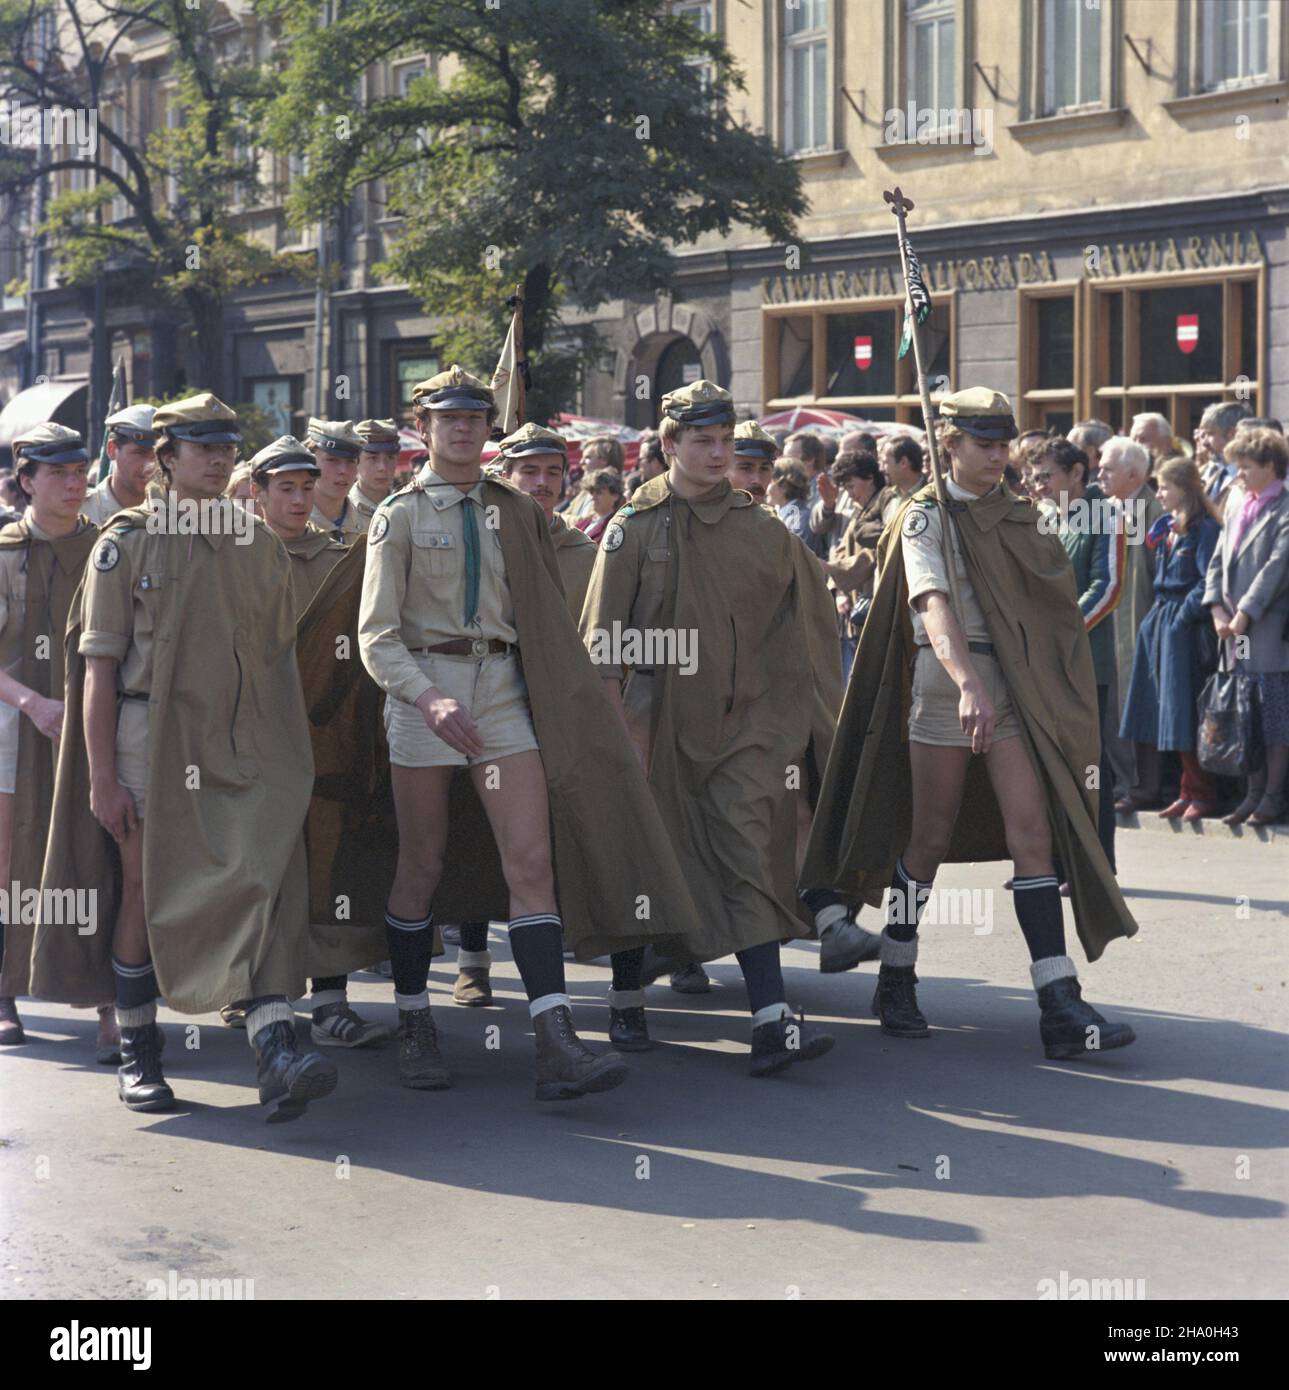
[583,474,841,960]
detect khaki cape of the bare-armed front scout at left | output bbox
[32,506,313,1013]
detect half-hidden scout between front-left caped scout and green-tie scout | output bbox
[229,435,394,1047]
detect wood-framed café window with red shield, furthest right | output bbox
[1089,270,1263,439]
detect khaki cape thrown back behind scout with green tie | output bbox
[314,474,694,974]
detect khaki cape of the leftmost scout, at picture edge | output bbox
[0,516,98,1004]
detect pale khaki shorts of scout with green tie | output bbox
[385,652,537,767]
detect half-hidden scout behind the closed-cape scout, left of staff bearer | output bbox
[723,420,882,992]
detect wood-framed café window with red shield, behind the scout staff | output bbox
[762,295,954,424]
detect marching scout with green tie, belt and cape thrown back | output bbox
[359,367,692,1099]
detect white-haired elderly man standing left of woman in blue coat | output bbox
[1101,430,1164,812]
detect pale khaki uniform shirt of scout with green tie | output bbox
[359,464,519,705]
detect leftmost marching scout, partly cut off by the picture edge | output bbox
[0,424,121,1050]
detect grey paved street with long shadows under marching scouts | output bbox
[0,831,1289,1298]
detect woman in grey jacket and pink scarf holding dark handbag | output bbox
[1204,430,1289,826]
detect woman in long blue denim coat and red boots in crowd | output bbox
[1119,456,1221,820]
